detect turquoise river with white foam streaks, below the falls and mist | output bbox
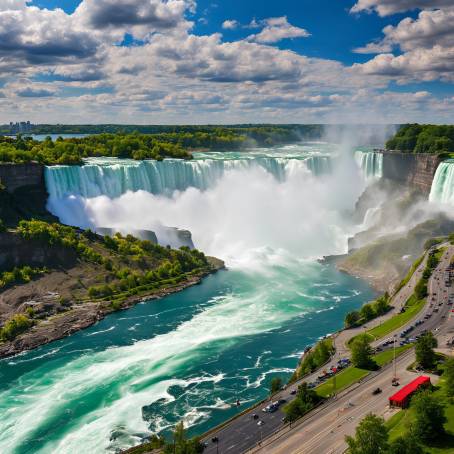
[0,263,373,454]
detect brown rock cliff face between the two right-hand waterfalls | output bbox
[383,152,441,195]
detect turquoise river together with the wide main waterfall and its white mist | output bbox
[0,143,374,454]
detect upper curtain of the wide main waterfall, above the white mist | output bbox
[45,155,331,199]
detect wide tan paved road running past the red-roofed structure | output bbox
[252,247,454,454]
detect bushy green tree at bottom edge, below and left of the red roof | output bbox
[345,414,388,454]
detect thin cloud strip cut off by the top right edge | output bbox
[350,0,453,17]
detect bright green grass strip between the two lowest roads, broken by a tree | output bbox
[316,344,413,398]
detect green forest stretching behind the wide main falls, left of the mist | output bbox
[0,126,320,165]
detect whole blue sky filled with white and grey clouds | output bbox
[0,0,454,124]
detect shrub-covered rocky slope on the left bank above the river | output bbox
[0,220,213,340]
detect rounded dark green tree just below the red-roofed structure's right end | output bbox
[411,390,446,442]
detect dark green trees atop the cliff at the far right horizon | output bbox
[386,124,454,154]
